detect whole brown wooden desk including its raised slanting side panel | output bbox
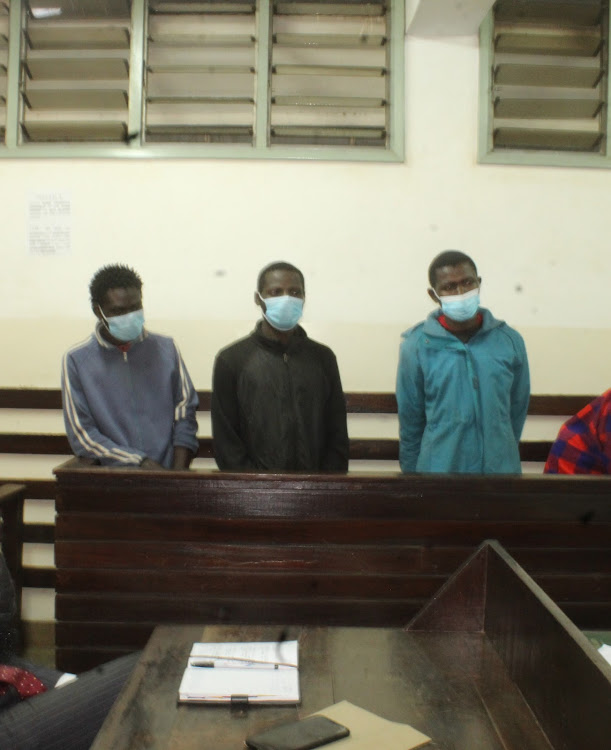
[92,542,611,750]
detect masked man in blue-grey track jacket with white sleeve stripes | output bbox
[62,265,198,469]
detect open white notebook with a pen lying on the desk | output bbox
[178,641,300,703]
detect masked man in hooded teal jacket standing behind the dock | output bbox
[397,250,530,474]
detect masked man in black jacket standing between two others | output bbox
[212,263,348,472]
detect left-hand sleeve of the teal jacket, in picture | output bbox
[397,338,426,474]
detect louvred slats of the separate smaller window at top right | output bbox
[489,0,609,155]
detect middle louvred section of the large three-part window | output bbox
[145,0,256,143]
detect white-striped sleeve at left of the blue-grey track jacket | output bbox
[61,353,147,466]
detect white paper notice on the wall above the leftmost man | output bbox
[28,192,72,255]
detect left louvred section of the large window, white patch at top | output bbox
[21,0,130,142]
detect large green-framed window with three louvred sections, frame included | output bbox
[0,0,405,161]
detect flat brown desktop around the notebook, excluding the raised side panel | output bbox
[87,626,550,750]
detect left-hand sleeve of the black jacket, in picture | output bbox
[211,355,256,471]
